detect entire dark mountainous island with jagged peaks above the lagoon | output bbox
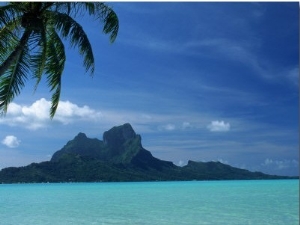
[0,123,291,183]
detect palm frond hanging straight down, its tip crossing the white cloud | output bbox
[45,30,66,118]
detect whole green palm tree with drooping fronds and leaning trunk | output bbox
[0,2,119,118]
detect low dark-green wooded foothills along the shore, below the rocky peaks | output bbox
[0,154,290,183]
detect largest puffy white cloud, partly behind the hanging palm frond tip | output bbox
[0,98,102,130]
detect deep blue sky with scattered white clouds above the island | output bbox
[0,2,299,175]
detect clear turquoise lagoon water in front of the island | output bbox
[0,180,299,225]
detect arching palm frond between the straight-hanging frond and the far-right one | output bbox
[52,13,95,74]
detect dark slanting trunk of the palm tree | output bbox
[0,30,32,78]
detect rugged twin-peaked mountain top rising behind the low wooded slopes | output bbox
[51,123,174,169]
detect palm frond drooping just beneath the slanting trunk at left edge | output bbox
[0,42,29,113]
